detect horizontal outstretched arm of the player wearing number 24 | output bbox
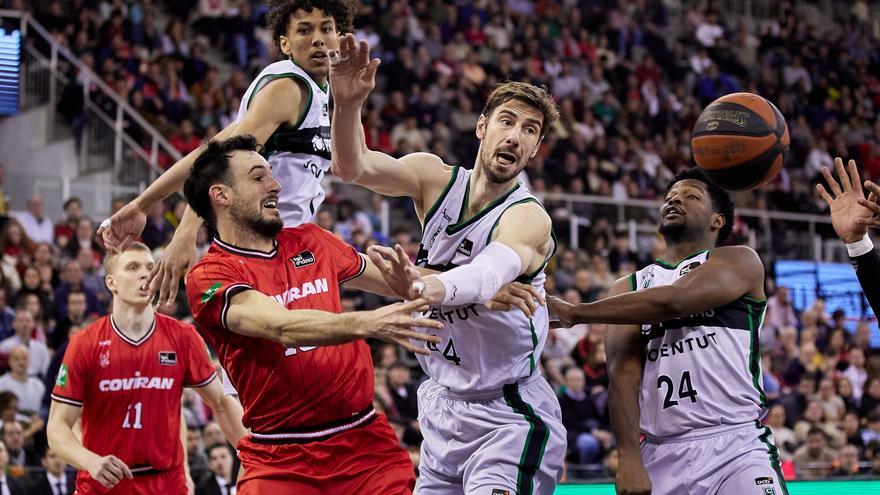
[547,246,764,326]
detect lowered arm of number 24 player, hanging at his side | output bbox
[605,277,651,494]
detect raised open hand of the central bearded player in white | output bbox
[330,34,379,105]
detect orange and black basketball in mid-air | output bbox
[691,93,791,191]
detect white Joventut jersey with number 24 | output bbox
[630,250,767,441]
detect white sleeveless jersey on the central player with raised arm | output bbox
[416,167,556,391]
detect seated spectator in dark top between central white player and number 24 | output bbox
[559,367,613,472]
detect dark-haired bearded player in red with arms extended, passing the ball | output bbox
[184,136,442,495]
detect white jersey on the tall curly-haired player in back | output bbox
[236,60,330,227]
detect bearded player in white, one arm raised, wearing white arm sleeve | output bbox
[330,35,566,495]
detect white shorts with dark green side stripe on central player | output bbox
[416,373,566,495]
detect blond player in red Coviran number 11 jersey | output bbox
[48,243,247,495]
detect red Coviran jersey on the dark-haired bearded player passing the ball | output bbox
[186,224,373,433]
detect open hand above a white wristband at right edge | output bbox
[816,158,880,244]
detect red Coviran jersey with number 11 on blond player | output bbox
[52,314,217,493]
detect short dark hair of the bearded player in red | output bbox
[183,134,258,227]
